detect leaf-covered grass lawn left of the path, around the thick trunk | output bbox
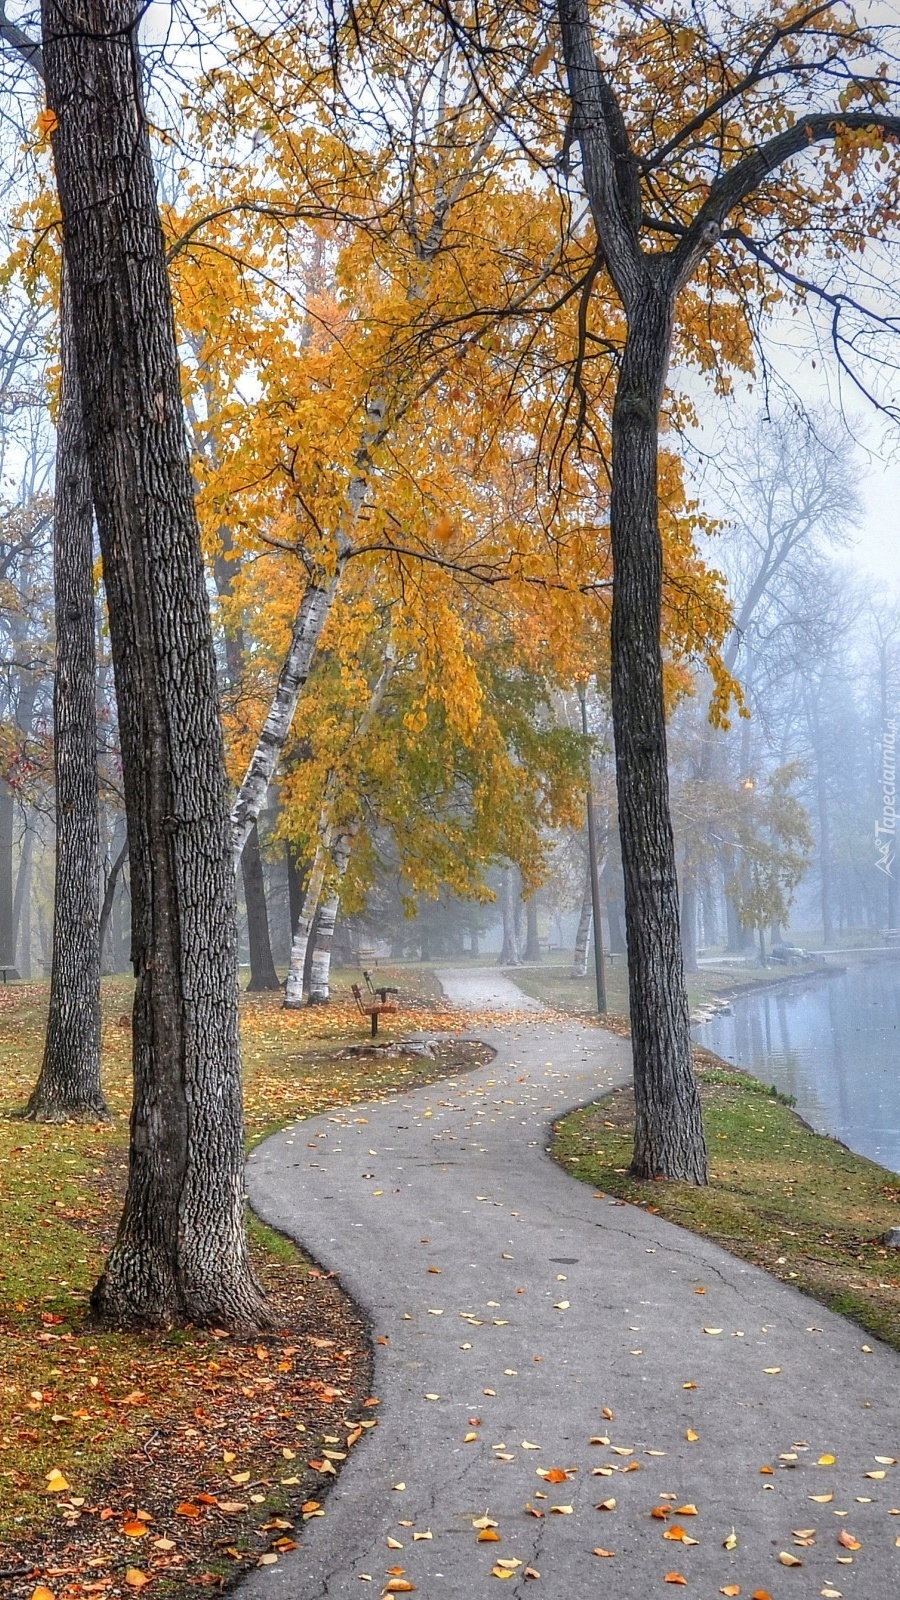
[0,970,485,1600]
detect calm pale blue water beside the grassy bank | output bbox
[695,960,900,1173]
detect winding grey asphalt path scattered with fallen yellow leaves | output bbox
[242,974,900,1600]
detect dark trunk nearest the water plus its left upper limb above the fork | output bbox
[559,0,709,1184]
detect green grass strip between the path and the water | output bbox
[551,1050,900,1350]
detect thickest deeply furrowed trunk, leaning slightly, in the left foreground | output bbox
[42,0,266,1325]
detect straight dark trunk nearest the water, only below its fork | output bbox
[610,294,706,1184]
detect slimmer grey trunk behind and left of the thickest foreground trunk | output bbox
[26,294,109,1122]
